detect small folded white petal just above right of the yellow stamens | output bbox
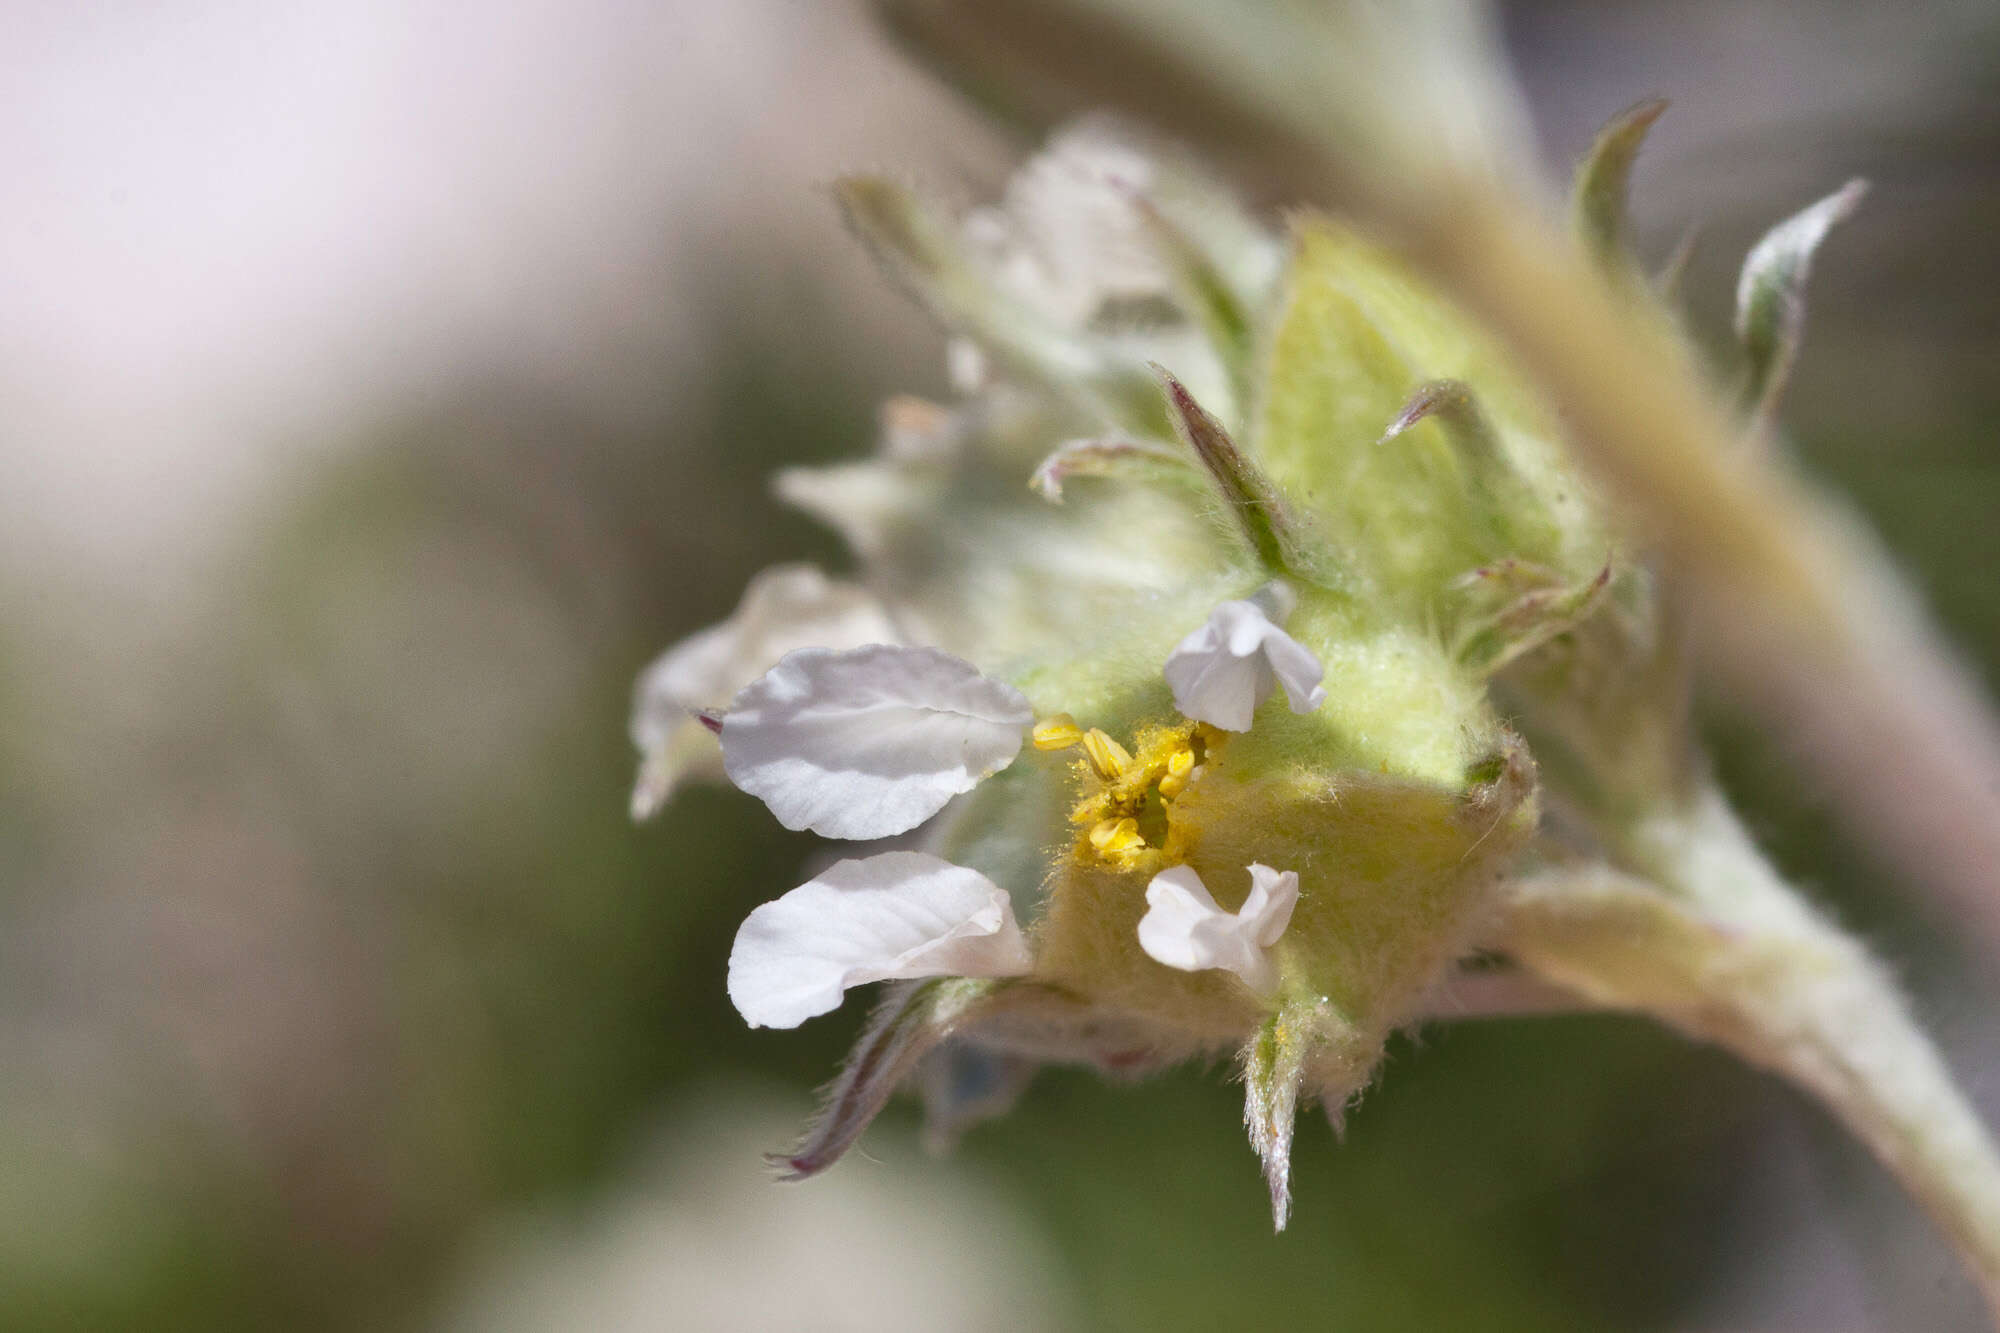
[1166,584,1326,731]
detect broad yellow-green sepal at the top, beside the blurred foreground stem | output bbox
[1250,216,1608,624]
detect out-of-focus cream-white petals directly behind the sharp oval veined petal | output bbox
[632,564,898,819]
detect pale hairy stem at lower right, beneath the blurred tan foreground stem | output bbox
[1500,793,2000,1321]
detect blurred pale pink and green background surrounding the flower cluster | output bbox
[0,0,2000,1331]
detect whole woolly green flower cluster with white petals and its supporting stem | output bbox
[634,106,2000,1296]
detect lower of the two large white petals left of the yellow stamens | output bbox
[730,851,1034,1027]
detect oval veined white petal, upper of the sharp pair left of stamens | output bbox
[722,644,1034,839]
